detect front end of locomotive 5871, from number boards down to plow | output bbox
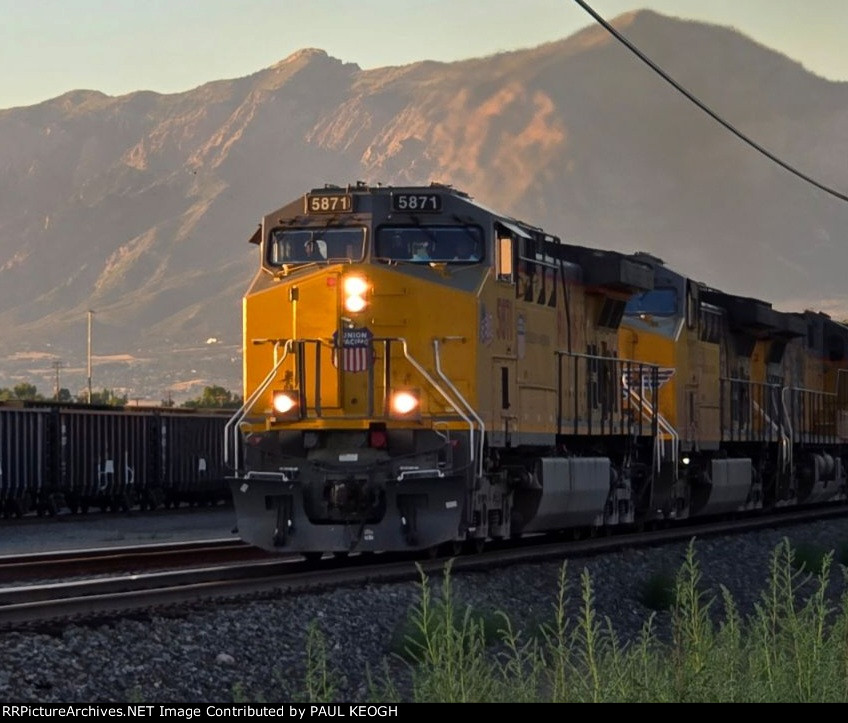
[227,185,489,552]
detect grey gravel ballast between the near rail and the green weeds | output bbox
[0,520,848,703]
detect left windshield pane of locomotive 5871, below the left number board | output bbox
[268,228,365,266]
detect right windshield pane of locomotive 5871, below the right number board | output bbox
[374,226,483,264]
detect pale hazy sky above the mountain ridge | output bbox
[0,0,848,108]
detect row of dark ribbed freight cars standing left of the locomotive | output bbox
[0,401,232,517]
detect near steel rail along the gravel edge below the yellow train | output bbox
[0,505,848,630]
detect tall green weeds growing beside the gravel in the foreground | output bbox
[290,540,848,703]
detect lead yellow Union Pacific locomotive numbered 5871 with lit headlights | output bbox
[227,183,662,556]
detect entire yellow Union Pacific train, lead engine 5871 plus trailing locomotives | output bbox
[224,183,848,557]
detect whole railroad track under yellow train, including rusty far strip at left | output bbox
[0,506,848,631]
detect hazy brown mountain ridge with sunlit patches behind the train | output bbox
[0,10,848,398]
